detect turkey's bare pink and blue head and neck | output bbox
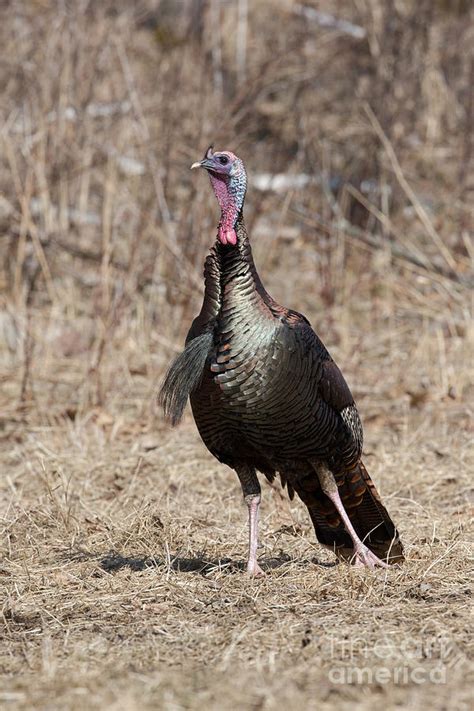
[191,146,247,245]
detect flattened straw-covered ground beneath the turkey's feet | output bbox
[1,326,473,709]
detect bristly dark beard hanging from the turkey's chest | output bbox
[158,331,213,427]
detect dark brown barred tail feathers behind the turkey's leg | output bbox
[295,461,404,563]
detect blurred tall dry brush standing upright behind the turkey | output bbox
[0,0,474,422]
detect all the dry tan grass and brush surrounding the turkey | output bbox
[0,0,474,711]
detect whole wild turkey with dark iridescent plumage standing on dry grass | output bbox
[159,146,403,575]
